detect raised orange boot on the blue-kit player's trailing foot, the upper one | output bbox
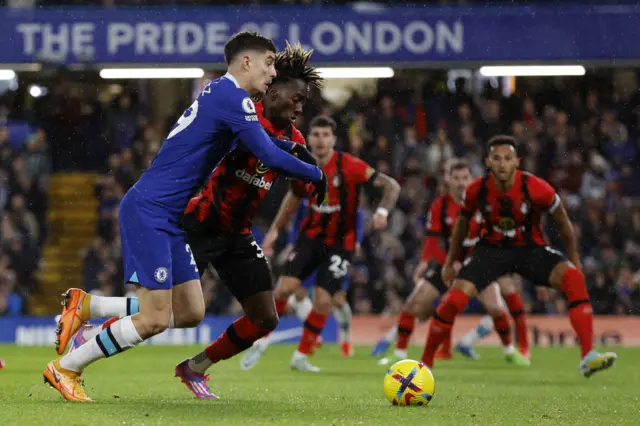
[56,288,91,355]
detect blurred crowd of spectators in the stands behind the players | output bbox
[0,65,640,315]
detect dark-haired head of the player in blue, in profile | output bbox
[224,31,276,95]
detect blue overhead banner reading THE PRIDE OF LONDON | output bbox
[0,5,640,66]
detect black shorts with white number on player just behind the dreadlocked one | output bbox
[283,237,353,295]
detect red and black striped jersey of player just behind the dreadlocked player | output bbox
[293,151,375,251]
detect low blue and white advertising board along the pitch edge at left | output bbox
[0,316,338,347]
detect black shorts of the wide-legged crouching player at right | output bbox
[456,244,567,292]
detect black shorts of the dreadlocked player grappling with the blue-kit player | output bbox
[183,215,273,302]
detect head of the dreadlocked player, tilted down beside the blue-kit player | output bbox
[263,43,322,128]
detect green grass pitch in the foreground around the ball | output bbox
[0,345,640,426]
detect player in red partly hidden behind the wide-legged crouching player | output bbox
[374,160,529,366]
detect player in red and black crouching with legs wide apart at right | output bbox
[422,135,616,377]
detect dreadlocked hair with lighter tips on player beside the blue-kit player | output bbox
[271,42,324,89]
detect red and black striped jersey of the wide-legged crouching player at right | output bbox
[462,170,560,247]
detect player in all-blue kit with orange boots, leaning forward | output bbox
[44,32,326,401]
